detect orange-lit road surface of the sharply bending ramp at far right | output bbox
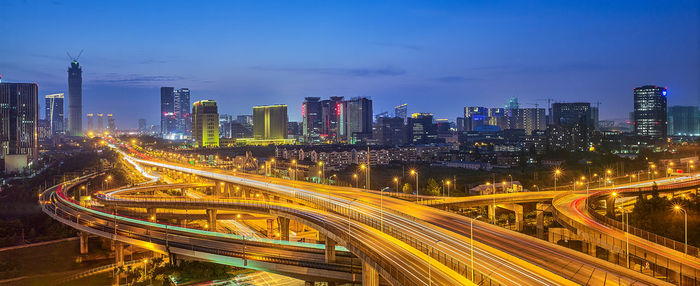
[554,175,700,280]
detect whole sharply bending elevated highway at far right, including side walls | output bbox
[553,176,700,285]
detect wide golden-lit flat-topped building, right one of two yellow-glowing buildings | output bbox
[253,104,289,140]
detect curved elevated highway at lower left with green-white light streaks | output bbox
[40,179,361,282]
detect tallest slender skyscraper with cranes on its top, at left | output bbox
[68,60,83,136]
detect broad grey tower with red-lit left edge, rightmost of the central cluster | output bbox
[339,97,372,143]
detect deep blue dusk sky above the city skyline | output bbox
[0,0,700,128]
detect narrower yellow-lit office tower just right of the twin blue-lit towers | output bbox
[192,100,219,147]
